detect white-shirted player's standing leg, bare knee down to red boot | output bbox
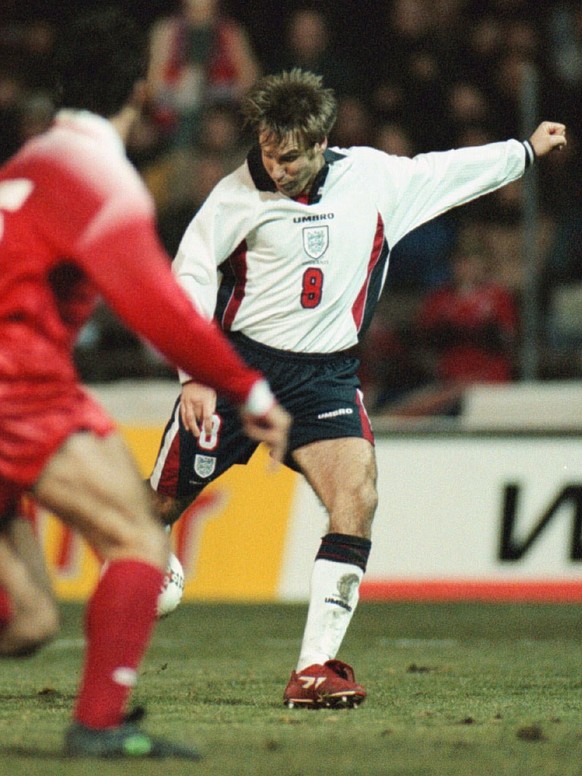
[285,437,378,707]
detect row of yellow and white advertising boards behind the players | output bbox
[37,383,582,602]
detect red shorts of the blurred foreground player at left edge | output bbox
[0,384,115,517]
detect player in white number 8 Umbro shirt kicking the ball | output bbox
[151,69,566,708]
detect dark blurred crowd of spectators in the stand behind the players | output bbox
[0,0,582,415]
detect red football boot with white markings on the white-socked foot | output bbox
[283,660,366,709]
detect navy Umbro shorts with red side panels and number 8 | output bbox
[150,334,374,498]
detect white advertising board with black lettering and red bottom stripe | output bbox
[279,434,582,600]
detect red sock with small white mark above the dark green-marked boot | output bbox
[74,560,164,728]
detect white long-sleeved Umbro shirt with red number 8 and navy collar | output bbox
[173,140,527,353]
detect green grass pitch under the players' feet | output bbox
[0,603,582,776]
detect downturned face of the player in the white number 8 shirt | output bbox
[259,132,327,197]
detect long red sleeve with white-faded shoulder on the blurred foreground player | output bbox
[23,138,262,403]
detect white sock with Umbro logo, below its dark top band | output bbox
[297,558,364,671]
